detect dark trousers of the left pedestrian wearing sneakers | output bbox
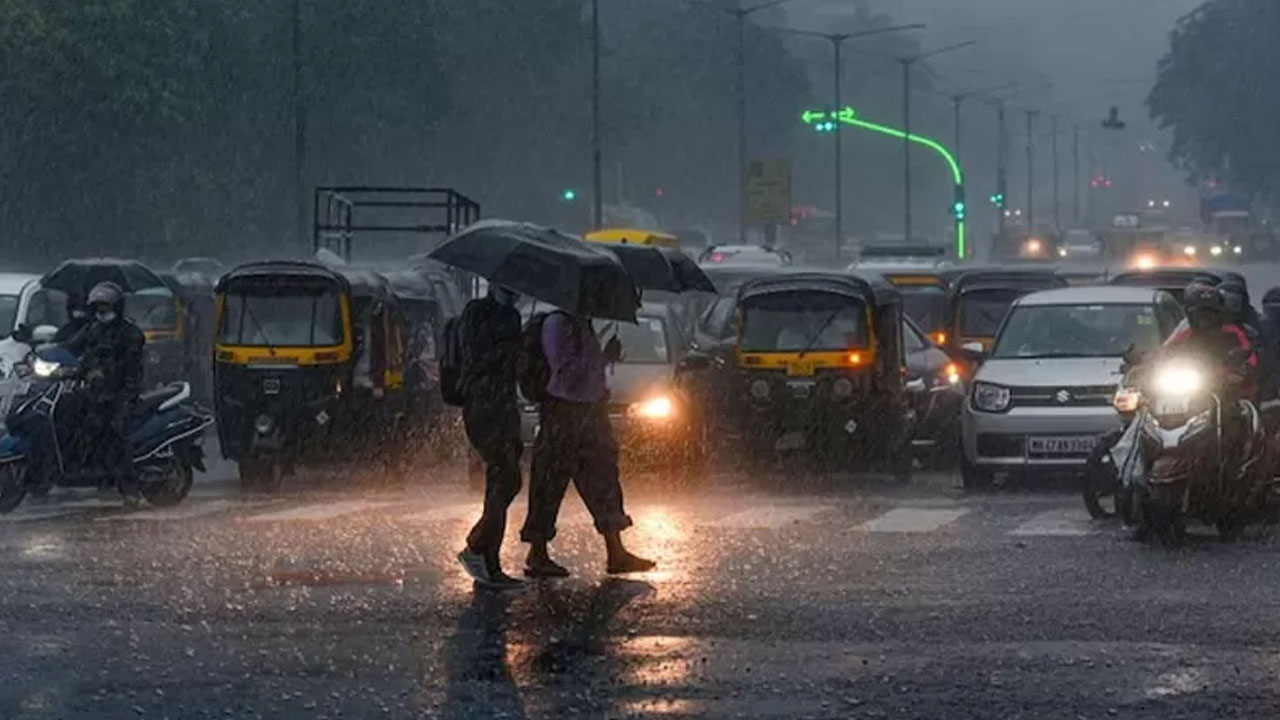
[462,402,521,561]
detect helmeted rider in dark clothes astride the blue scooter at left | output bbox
[67,282,146,506]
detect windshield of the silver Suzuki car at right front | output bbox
[991,304,1161,357]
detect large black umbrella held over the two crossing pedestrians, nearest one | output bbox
[428,220,640,322]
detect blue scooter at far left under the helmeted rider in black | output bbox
[0,345,214,512]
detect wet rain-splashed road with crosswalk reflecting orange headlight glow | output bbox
[0,466,1280,720]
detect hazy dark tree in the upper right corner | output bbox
[1147,0,1280,202]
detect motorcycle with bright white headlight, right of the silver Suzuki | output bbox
[1117,348,1274,546]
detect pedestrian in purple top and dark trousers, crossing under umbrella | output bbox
[520,313,657,578]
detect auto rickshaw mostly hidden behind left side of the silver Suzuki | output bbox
[943,269,1069,356]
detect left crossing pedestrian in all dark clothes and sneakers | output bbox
[457,286,521,588]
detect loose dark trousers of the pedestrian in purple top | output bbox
[520,398,631,542]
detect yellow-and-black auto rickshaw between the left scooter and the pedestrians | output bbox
[214,261,407,489]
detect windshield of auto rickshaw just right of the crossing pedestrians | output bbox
[740,291,867,352]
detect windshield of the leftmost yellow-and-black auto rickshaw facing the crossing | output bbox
[218,284,343,347]
